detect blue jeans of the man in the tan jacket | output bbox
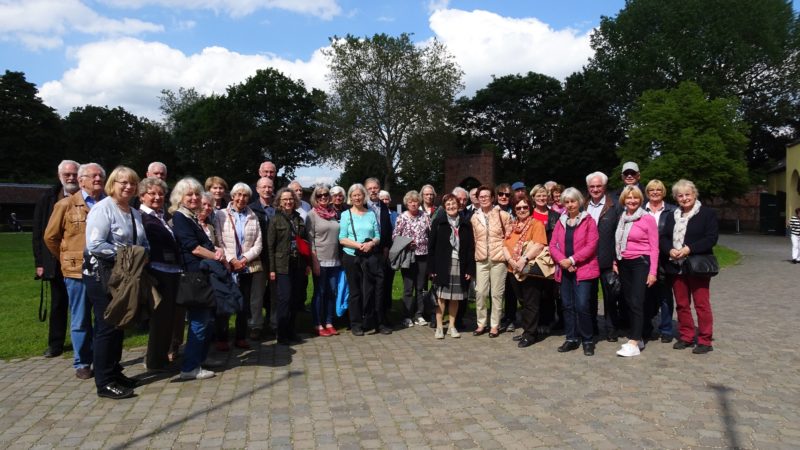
[64,278,94,369]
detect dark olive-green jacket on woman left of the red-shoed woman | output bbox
[267,211,308,274]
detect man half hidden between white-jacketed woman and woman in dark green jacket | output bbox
[247,176,278,340]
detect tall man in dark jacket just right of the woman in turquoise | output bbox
[364,178,396,333]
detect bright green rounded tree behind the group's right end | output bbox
[617,82,748,198]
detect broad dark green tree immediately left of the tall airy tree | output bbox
[170,69,325,183]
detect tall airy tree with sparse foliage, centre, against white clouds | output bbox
[323,33,462,189]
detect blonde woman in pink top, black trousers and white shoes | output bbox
[614,186,658,357]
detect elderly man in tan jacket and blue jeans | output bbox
[44,163,106,380]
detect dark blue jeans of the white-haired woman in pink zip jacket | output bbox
[561,272,593,343]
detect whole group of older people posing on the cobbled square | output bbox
[33,160,717,399]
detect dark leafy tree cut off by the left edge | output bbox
[0,70,63,183]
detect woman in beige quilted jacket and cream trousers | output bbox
[470,186,511,338]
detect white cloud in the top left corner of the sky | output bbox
[0,0,164,50]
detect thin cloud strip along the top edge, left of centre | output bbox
[102,0,342,20]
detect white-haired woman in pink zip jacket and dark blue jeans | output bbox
[550,188,600,356]
